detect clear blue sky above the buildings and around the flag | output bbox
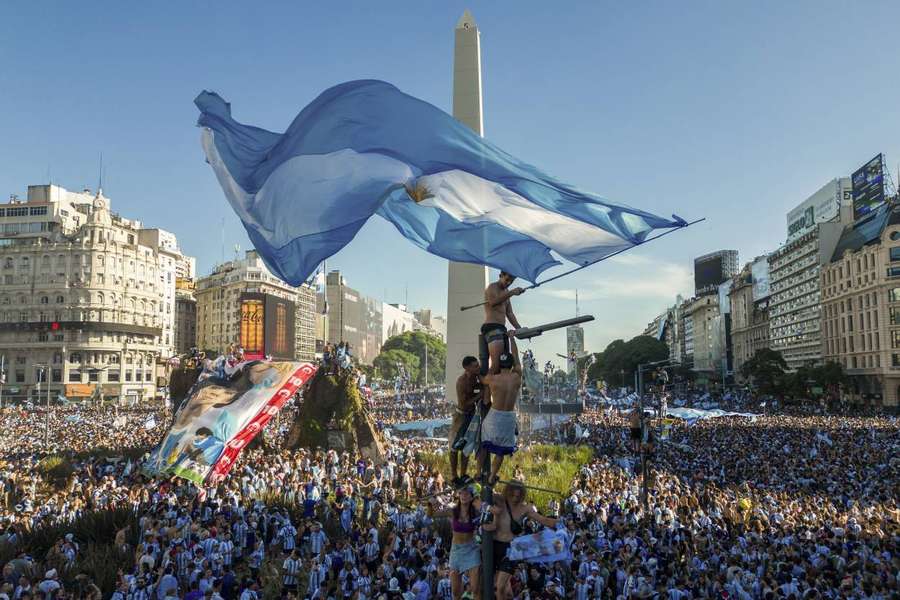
[0,1,900,368]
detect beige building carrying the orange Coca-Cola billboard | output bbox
[194,250,315,360]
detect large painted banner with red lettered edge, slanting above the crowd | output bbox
[144,361,317,484]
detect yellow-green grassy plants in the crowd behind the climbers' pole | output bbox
[421,444,594,511]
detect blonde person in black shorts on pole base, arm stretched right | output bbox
[484,481,557,600]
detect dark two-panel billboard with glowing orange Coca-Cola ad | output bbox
[239,294,295,360]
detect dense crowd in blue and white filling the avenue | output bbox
[0,386,900,600]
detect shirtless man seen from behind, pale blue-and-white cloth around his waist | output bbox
[479,332,522,482]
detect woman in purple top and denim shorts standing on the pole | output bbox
[428,485,481,600]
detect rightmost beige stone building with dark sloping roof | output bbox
[819,204,900,412]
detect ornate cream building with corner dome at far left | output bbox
[0,184,190,402]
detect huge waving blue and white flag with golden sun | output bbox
[195,80,685,285]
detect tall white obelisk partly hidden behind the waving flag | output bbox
[446,10,488,403]
